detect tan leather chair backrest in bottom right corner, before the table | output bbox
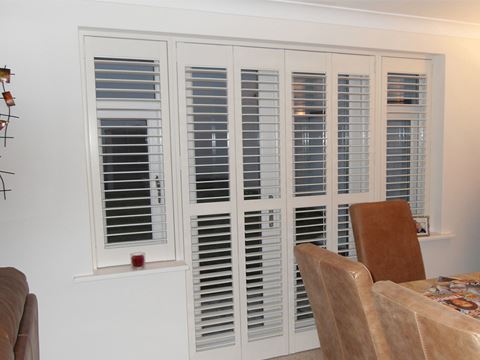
[373,281,480,360]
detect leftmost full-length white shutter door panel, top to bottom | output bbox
[177,43,242,359]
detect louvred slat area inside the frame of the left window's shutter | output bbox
[94,58,167,244]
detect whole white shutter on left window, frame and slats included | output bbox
[86,38,174,267]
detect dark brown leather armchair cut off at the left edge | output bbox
[0,268,39,360]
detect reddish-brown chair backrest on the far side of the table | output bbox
[350,200,425,283]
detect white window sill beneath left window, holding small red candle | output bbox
[73,261,188,282]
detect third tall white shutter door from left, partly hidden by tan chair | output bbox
[286,51,332,351]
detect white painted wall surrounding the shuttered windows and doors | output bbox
[0,0,480,360]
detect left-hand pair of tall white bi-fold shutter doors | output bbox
[177,43,288,359]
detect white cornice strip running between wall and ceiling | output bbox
[96,0,480,38]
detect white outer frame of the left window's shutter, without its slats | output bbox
[84,36,175,268]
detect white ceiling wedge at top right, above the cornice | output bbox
[272,0,480,24]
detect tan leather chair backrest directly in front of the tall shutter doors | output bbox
[295,244,390,360]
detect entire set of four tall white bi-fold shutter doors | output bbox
[178,44,373,359]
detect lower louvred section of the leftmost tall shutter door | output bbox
[191,214,235,351]
